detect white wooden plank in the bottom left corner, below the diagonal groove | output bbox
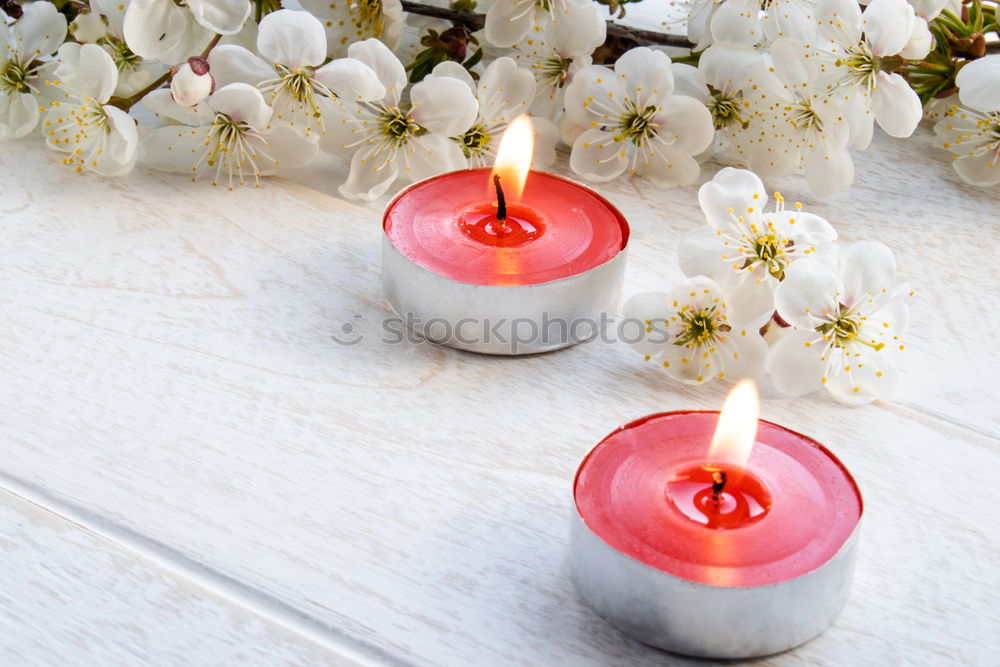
[0,491,361,667]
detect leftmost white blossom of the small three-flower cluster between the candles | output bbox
[622,276,767,384]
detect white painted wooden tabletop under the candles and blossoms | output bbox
[0,130,1000,666]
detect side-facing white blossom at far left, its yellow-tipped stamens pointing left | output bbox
[43,42,139,176]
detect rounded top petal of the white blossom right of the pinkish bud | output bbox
[258,5,326,69]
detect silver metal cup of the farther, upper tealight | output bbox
[382,174,628,355]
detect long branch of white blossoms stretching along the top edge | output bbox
[0,0,1000,193]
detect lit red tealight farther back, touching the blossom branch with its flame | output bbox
[382,116,629,354]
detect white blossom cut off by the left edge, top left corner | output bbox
[0,2,66,139]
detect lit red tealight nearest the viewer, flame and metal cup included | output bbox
[572,381,862,658]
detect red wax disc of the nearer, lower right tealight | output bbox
[574,412,862,587]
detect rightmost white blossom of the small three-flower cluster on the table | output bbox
[765,241,909,405]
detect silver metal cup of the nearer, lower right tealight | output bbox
[570,420,861,659]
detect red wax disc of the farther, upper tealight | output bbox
[383,169,629,285]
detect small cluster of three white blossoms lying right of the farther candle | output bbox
[624,167,911,405]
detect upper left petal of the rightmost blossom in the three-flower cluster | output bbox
[774,258,840,330]
